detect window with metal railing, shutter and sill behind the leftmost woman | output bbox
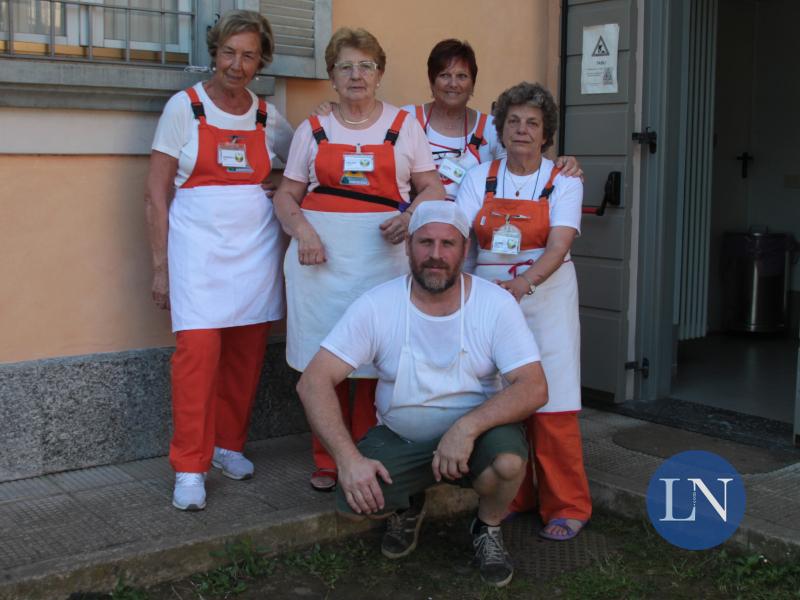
[0,0,332,111]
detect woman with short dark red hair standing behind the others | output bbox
[403,39,582,200]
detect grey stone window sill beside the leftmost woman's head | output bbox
[0,57,275,112]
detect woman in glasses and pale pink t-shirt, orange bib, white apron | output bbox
[275,28,444,491]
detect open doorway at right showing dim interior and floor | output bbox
[645,0,800,444]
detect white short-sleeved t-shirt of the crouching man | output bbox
[321,276,540,441]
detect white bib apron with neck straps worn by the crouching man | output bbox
[376,275,486,442]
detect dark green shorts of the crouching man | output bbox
[336,423,528,513]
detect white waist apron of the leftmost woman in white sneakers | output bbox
[167,185,285,331]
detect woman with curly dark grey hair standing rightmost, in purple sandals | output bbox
[456,83,591,540]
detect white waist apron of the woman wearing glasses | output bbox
[283,210,408,372]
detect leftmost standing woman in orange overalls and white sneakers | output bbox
[145,11,286,510]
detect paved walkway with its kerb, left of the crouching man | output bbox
[0,434,476,600]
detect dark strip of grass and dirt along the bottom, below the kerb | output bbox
[92,512,800,600]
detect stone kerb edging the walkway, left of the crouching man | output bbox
[0,485,477,600]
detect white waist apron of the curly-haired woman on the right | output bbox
[475,249,581,413]
